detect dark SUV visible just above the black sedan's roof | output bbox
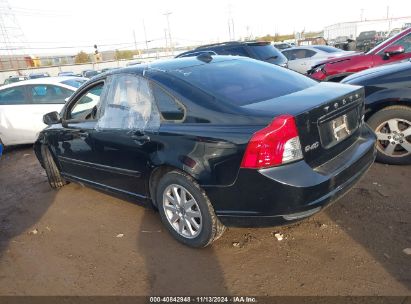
[176,41,288,67]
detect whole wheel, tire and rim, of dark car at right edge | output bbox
[367,106,411,165]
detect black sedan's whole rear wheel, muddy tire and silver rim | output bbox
[156,171,225,248]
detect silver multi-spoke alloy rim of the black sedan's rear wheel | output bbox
[163,184,202,239]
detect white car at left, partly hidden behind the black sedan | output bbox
[0,77,87,146]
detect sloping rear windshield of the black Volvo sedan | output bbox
[171,59,317,106]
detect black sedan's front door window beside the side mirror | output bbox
[68,82,104,120]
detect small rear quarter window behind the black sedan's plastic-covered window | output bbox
[152,83,184,121]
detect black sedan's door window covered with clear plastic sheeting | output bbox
[96,74,160,130]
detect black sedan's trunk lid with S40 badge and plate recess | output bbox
[243,83,364,168]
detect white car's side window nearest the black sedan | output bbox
[30,85,74,104]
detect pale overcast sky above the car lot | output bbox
[1,0,411,53]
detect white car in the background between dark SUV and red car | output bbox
[282,45,355,74]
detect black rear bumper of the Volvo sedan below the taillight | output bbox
[204,124,376,226]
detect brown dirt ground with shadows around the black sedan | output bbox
[0,147,411,296]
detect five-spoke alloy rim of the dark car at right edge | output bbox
[375,118,411,157]
